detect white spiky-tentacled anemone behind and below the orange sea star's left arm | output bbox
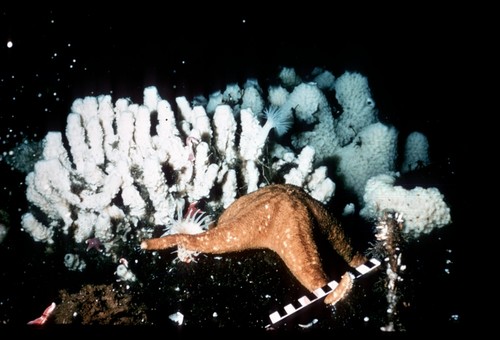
[162,207,212,263]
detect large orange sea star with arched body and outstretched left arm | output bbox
[141,184,366,304]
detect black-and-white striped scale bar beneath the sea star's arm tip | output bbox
[266,259,380,328]
